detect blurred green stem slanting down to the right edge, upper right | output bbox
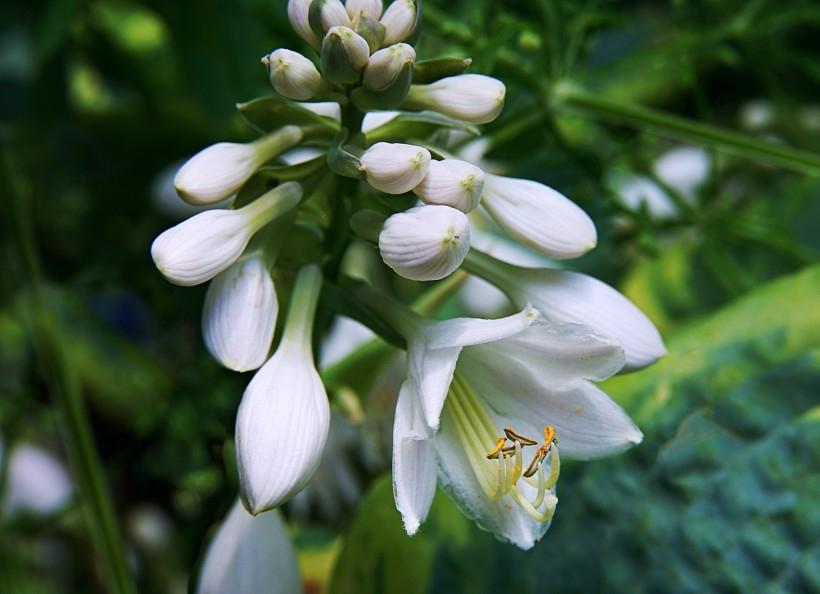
[555,85,820,175]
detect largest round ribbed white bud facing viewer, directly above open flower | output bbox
[379,205,470,281]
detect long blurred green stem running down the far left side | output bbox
[0,152,136,594]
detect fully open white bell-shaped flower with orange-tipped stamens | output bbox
[362,303,642,549]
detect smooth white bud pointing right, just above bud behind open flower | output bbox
[481,175,598,259]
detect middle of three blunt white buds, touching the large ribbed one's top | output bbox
[413,159,484,212]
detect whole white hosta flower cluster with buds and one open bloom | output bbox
[152,0,664,564]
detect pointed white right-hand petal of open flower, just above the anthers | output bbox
[458,354,643,460]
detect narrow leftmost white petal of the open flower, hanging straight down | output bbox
[393,381,436,536]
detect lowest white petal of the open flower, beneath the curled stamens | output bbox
[434,404,550,549]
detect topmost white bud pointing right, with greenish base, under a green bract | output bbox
[405,74,506,124]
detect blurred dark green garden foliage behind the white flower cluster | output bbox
[0,0,820,594]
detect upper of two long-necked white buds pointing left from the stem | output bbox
[174,126,303,205]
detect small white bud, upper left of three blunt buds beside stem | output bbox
[361,142,430,194]
